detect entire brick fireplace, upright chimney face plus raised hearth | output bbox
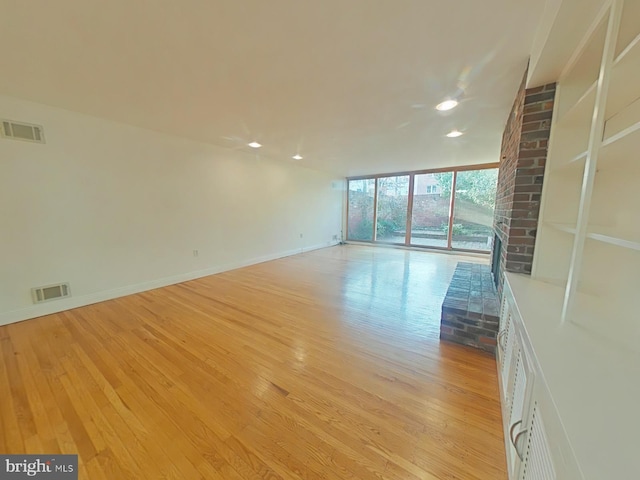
[440,69,556,352]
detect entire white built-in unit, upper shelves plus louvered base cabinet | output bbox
[498,0,640,480]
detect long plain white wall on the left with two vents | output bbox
[0,96,343,324]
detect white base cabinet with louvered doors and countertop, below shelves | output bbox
[497,273,640,480]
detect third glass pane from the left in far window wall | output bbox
[411,172,453,248]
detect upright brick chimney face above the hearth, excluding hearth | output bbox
[494,72,556,296]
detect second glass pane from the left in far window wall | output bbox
[376,175,409,244]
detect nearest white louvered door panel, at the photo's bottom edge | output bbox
[520,403,556,480]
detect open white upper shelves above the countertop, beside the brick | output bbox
[533,0,640,338]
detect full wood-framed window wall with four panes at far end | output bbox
[347,164,498,252]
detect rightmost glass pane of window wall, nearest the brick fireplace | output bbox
[451,168,498,251]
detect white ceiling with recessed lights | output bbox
[0,0,544,175]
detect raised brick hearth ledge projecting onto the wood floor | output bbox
[440,262,499,353]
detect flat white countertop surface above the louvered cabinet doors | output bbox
[506,273,640,480]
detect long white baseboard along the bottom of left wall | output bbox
[0,241,338,326]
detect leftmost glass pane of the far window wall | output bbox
[347,178,376,242]
